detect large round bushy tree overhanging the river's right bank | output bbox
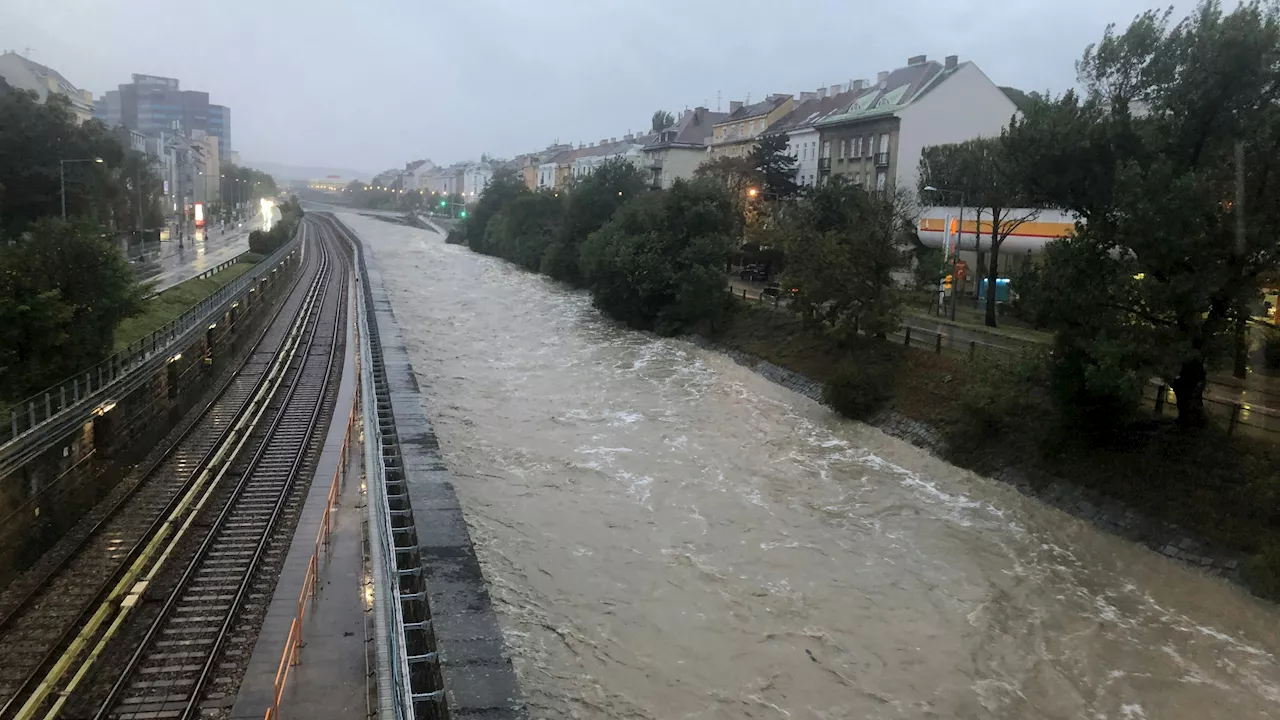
[581,181,733,334]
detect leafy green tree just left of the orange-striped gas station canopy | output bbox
[781,176,908,341]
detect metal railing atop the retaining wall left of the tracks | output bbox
[0,236,298,451]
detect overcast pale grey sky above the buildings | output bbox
[0,0,1185,172]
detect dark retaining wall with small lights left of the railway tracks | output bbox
[0,250,300,587]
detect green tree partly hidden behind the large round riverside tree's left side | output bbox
[541,158,646,284]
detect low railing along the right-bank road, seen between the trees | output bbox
[728,287,1280,442]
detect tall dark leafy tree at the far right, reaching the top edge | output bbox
[1005,1,1280,427]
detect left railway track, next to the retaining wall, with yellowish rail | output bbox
[0,223,340,717]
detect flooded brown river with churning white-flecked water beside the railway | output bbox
[347,217,1280,720]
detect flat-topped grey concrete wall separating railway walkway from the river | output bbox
[351,219,527,720]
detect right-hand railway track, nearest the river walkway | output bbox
[76,224,347,720]
